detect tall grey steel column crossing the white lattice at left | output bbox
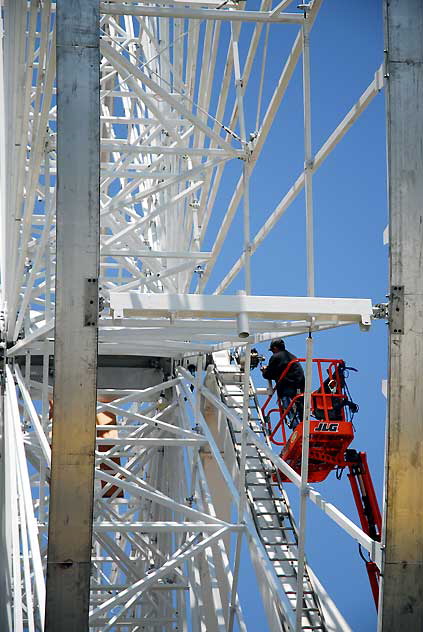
[46,0,100,632]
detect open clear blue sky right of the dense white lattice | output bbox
[205,0,388,632]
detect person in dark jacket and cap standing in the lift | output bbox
[261,338,305,428]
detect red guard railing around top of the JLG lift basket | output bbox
[261,358,348,446]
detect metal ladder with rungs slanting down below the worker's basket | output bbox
[213,352,327,632]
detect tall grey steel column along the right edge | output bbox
[379,0,423,632]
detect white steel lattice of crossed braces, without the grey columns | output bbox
[0,0,383,632]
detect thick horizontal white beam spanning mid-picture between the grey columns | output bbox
[110,291,372,327]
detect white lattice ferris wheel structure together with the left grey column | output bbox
[0,0,420,632]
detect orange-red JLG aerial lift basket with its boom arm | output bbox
[261,358,382,608]
